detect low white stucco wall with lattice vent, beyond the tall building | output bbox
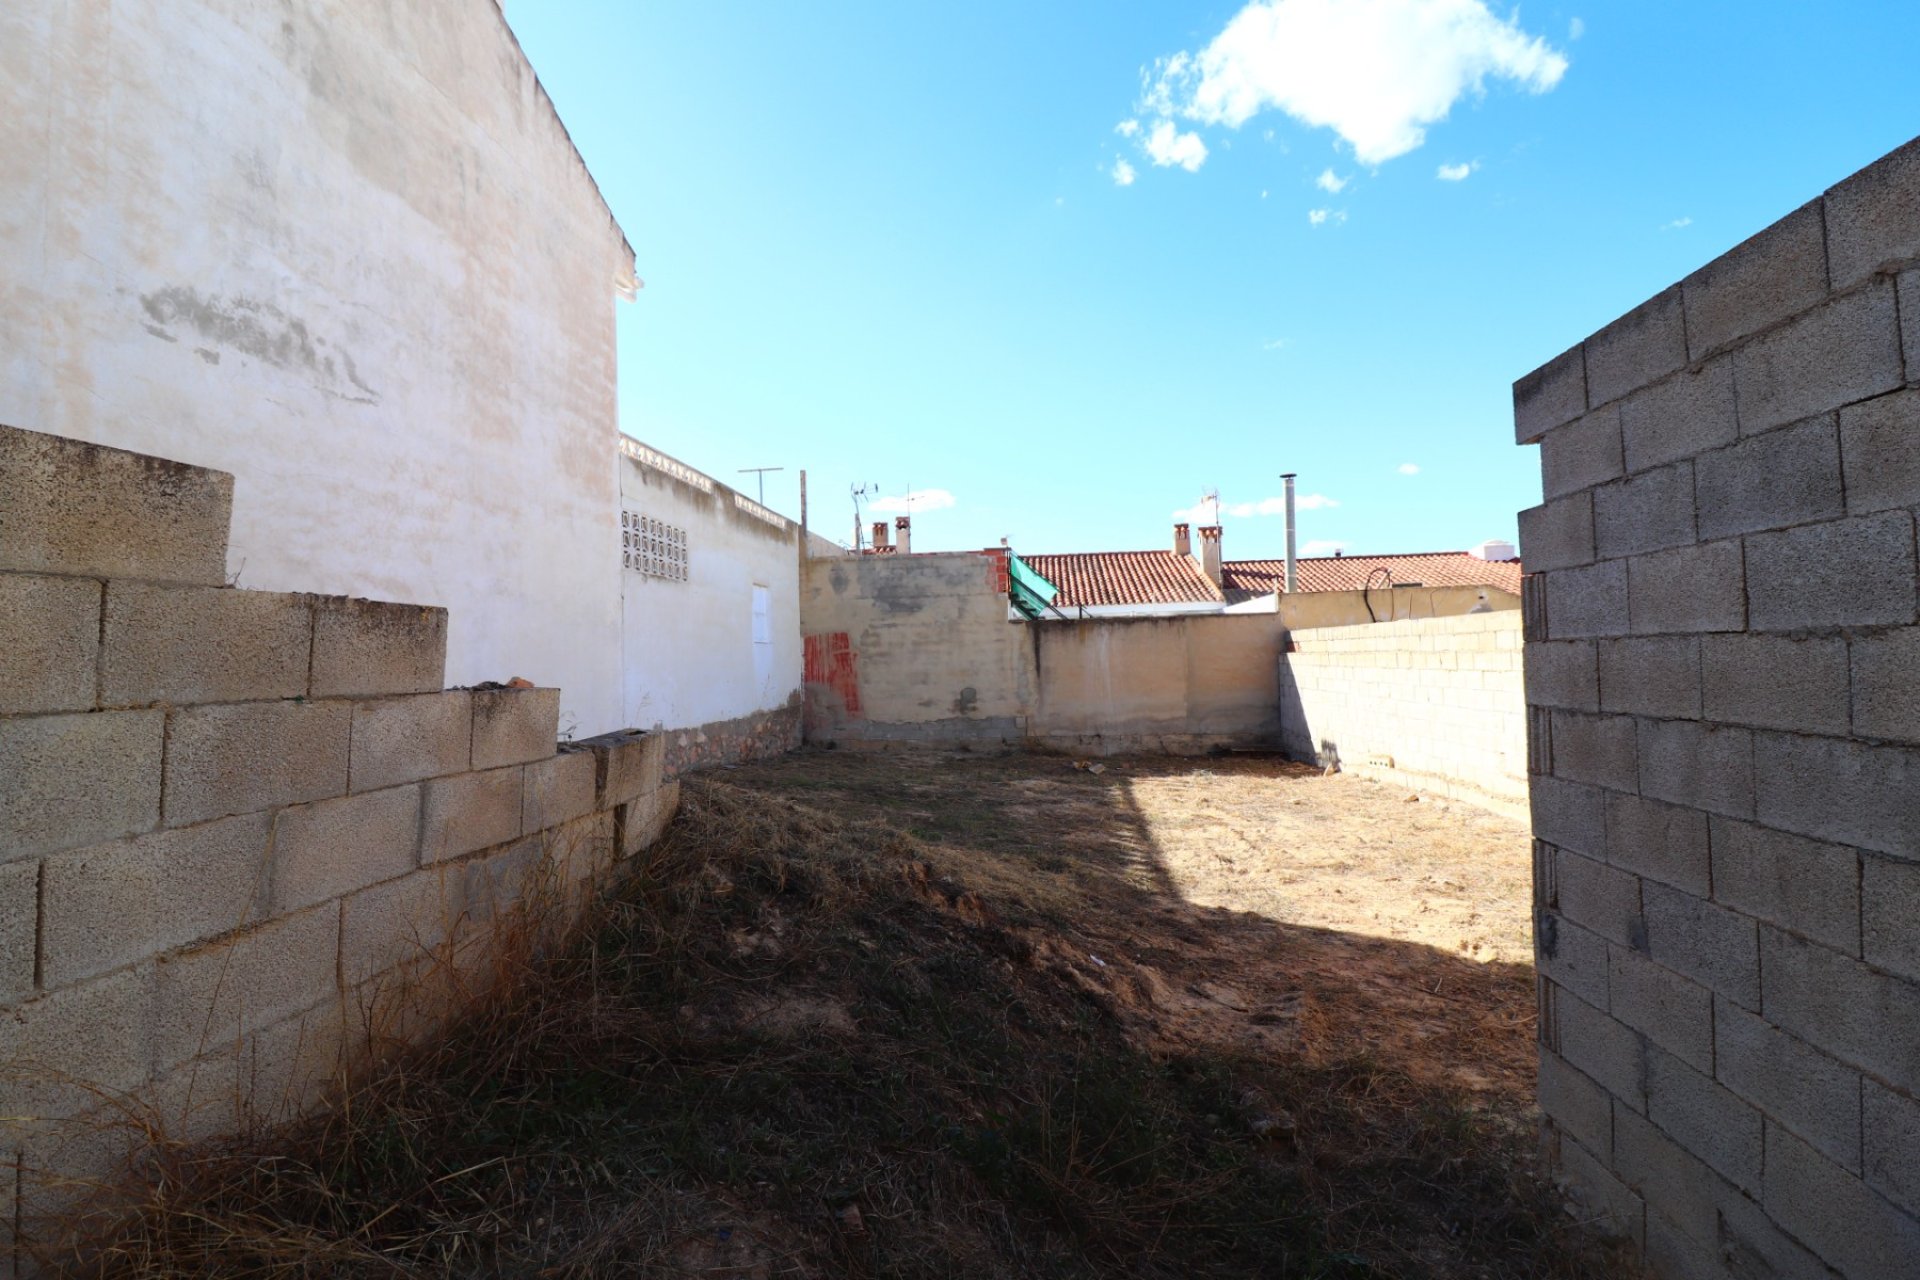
[620,441,801,729]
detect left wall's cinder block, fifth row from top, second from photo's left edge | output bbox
[154,904,340,1071]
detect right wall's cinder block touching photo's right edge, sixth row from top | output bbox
[1753,733,1920,858]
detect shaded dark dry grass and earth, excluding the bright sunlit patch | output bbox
[48,754,1613,1280]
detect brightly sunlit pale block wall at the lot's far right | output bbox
[1281,610,1526,810]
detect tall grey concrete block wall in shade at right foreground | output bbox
[1513,132,1920,1280]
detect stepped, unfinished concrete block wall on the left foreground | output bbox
[0,428,678,1274]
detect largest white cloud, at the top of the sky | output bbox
[1139,0,1567,169]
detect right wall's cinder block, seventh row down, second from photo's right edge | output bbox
[1713,818,1860,956]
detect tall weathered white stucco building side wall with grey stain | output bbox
[0,0,634,733]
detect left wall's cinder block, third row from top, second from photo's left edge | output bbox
[165,702,351,827]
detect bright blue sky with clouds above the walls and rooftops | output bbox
[507,0,1920,558]
